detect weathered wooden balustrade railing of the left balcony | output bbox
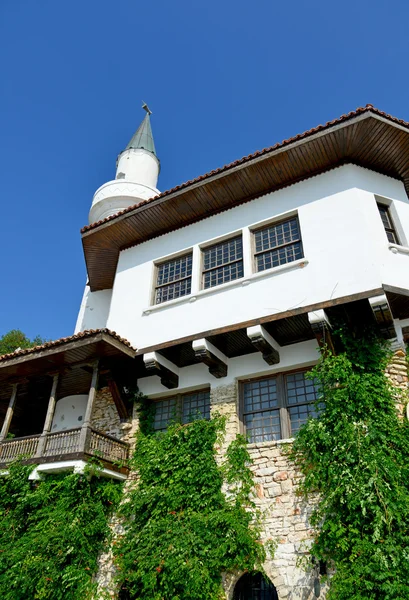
[0,428,128,466]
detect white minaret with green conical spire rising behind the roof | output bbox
[89,104,160,223]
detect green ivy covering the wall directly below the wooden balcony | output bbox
[0,464,121,600]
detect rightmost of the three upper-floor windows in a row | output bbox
[254,217,304,271]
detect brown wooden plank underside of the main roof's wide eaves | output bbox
[82,112,409,291]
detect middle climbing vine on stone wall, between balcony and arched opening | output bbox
[115,406,264,600]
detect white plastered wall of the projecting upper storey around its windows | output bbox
[97,165,409,348]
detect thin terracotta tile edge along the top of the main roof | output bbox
[81,104,409,233]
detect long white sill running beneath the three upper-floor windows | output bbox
[142,256,308,316]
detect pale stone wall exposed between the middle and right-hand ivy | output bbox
[210,383,316,600]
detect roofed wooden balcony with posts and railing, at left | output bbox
[0,330,135,479]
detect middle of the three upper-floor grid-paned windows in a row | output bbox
[203,236,243,289]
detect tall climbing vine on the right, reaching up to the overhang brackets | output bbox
[292,326,409,600]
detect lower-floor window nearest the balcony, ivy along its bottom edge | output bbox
[153,390,210,431]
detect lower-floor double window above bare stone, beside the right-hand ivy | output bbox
[242,371,324,442]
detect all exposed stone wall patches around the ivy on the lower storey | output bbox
[93,347,408,600]
